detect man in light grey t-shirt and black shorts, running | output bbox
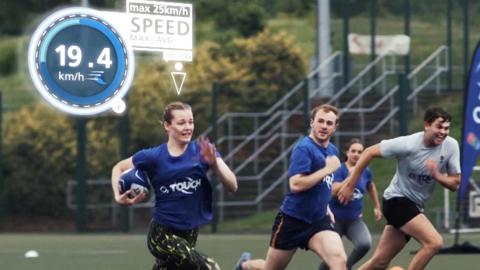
[337,108,460,270]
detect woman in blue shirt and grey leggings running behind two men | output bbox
[320,139,382,269]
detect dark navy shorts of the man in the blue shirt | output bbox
[270,212,335,250]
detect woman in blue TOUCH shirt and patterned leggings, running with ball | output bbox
[112,102,237,270]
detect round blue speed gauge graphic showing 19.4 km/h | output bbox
[28,8,135,115]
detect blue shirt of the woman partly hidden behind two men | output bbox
[330,163,372,220]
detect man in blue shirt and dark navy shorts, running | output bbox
[265,105,346,270]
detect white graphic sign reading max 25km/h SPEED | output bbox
[104,0,193,62]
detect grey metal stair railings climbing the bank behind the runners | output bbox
[217,51,404,219]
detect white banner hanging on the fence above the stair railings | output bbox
[348,34,410,55]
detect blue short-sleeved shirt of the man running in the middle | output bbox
[280,136,338,224]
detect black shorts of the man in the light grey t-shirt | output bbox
[382,197,421,229]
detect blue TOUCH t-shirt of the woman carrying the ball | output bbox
[133,141,213,230]
